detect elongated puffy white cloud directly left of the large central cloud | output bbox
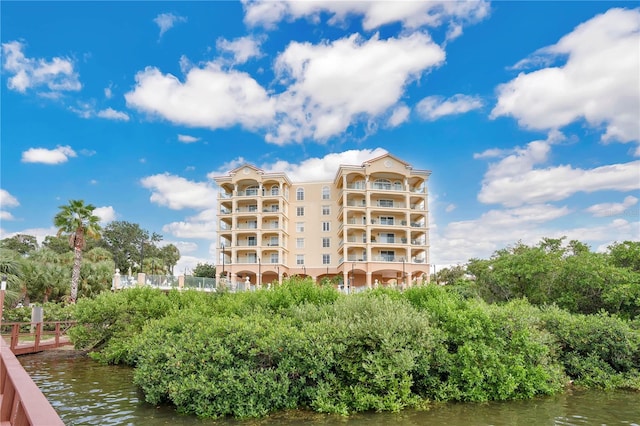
[125,62,275,129]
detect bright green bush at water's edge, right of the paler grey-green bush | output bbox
[405,286,564,401]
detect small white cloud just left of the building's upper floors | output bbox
[140,173,217,210]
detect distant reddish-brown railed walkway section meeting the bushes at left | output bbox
[2,321,76,355]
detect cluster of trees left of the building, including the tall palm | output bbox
[0,200,180,305]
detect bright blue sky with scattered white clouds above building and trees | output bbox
[0,0,640,273]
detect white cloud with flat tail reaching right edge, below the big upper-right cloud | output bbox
[476,133,640,207]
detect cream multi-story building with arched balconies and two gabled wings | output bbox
[215,154,431,287]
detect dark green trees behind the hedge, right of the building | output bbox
[432,237,640,318]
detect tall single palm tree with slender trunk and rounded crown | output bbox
[53,200,102,303]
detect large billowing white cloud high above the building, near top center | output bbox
[266,33,445,144]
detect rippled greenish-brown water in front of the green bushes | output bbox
[19,351,640,426]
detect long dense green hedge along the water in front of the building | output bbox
[72,280,640,417]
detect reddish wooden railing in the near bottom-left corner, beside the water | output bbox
[0,338,64,426]
